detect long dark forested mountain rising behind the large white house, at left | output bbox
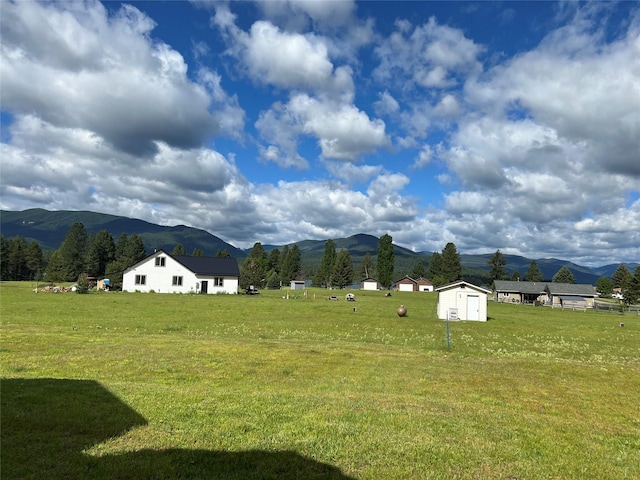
[0,208,246,257]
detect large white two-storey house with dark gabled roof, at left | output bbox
[122,250,240,293]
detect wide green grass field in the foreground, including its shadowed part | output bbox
[0,283,640,480]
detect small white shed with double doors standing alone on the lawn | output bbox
[436,280,491,322]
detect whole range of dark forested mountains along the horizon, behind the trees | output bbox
[0,208,638,285]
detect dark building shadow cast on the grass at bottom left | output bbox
[0,379,352,480]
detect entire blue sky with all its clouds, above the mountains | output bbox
[0,0,640,266]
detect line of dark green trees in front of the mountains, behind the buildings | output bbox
[0,222,640,302]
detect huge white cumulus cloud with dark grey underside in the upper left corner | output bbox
[0,2,242,156]
